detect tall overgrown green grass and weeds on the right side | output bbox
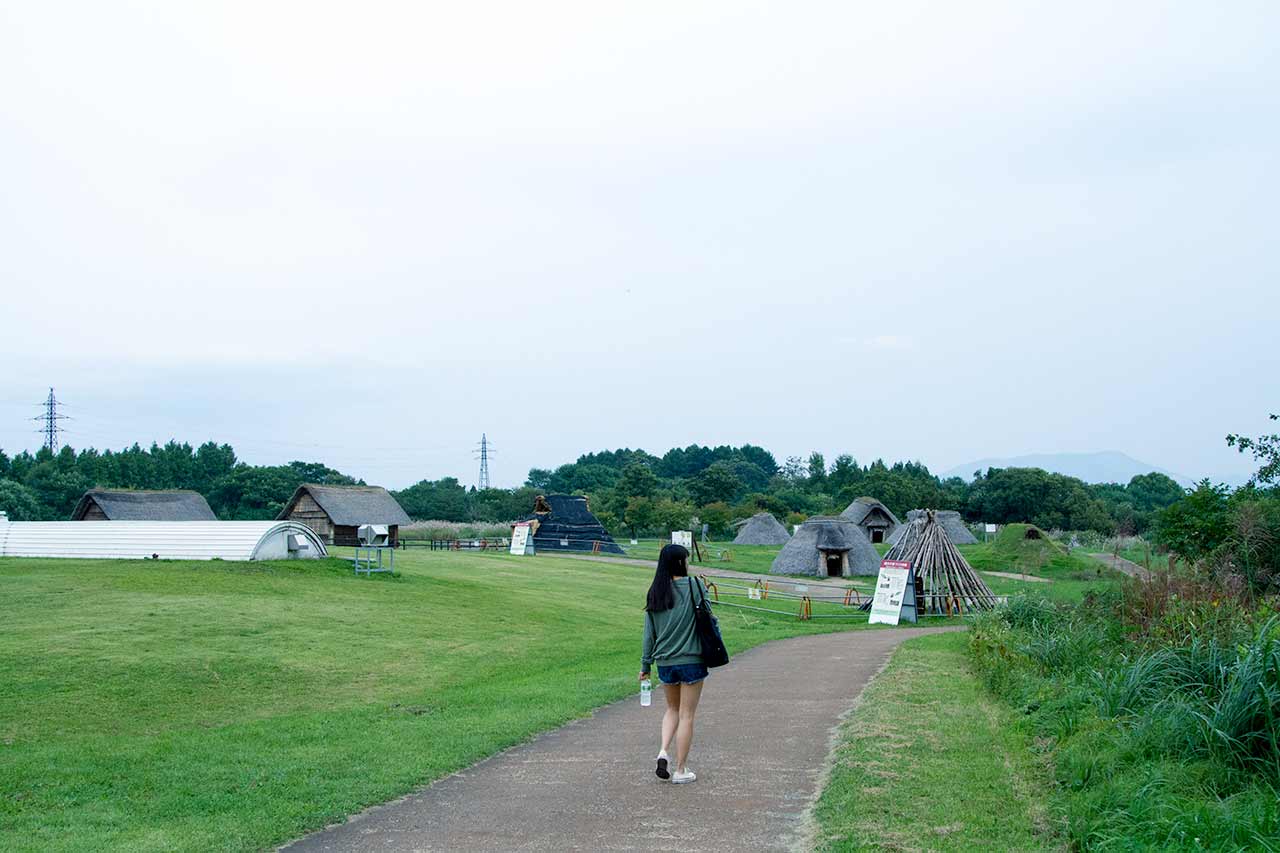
[970,581,1280,850]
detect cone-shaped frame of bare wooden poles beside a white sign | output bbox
[884,510,998,607]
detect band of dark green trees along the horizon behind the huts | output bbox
[0,442,1184,535]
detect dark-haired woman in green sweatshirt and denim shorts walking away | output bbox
[640,544,714,784]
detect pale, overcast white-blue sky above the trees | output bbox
[0,0,1280,487]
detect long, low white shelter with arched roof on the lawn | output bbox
[0,521,329,560]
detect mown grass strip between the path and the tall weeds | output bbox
[814,633,1065,850]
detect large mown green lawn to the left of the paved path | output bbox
[0,551,952,850]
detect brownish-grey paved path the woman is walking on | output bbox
[287,628,947,853]
